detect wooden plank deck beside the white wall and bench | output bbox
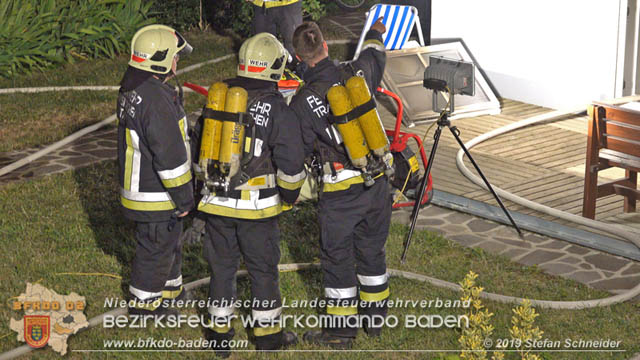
[380,99,640,240]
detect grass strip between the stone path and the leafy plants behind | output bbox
[0,31,235,153]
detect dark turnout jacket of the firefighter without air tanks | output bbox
[117,76,195,222]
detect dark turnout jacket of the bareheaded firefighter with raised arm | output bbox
[290,30,386,193]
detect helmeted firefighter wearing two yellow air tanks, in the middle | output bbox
[198,33,306,356]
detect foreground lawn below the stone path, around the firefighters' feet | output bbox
[0,162,640,359]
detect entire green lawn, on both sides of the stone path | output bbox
[0,12,640,359]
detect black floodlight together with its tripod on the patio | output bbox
[401,56,522,264]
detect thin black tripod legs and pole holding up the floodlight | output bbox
[401,90,522,264]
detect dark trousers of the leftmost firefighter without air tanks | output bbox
[129,218,182,311]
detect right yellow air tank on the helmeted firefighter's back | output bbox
[219,86,248,176]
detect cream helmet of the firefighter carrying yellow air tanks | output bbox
[238,33,288,82]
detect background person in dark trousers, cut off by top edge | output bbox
[246,0,302,61]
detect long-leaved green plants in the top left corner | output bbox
[0,0,152,77]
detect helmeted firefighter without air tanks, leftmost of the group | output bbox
[117,25,195,314]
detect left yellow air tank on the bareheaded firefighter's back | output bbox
[327,85,369,168]
